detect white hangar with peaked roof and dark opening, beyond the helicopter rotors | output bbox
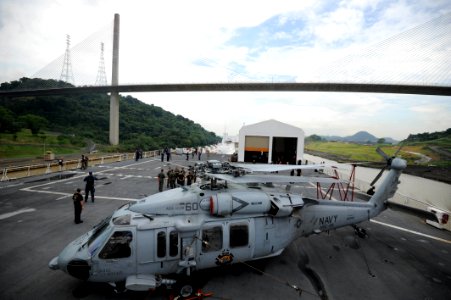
[238,120,305,164]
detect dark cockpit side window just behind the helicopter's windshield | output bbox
[99,231,133,259]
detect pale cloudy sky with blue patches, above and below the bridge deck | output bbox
[0,0,451,140]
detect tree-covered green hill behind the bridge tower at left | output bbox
[0,78,220,155]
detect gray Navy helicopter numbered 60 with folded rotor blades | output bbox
[49,149,406,296]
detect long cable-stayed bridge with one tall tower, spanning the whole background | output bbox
[0,13,451,144]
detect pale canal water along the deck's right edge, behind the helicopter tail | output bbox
[304,154,451,212]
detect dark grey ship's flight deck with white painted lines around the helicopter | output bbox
[0,155,451,300]
